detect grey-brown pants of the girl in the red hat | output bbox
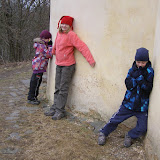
[52,64,75,112]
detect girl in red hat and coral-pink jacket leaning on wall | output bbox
[45,16,95,120]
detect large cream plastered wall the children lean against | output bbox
[47,0,160,157]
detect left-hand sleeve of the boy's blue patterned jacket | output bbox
[125,69,137,90]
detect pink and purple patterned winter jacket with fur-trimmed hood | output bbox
[32,38,52,73]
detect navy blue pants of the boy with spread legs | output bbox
[100,105,148,139]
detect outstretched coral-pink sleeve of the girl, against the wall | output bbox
[69,31,95,64]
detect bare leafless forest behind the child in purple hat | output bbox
[0,0,50,63]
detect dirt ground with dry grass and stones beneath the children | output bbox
[0,62,147,160]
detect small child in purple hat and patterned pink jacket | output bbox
[28,30,52,105]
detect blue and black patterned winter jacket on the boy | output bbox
[122,61,154,112]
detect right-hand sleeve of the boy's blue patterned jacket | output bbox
[140,68,154,93]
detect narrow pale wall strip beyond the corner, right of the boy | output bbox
[146,1,160,159]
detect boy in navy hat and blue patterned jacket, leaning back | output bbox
[98,48,154,147]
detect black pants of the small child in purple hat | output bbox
[28,73,43,100]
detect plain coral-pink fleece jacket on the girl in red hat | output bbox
[52,31,95,66]
